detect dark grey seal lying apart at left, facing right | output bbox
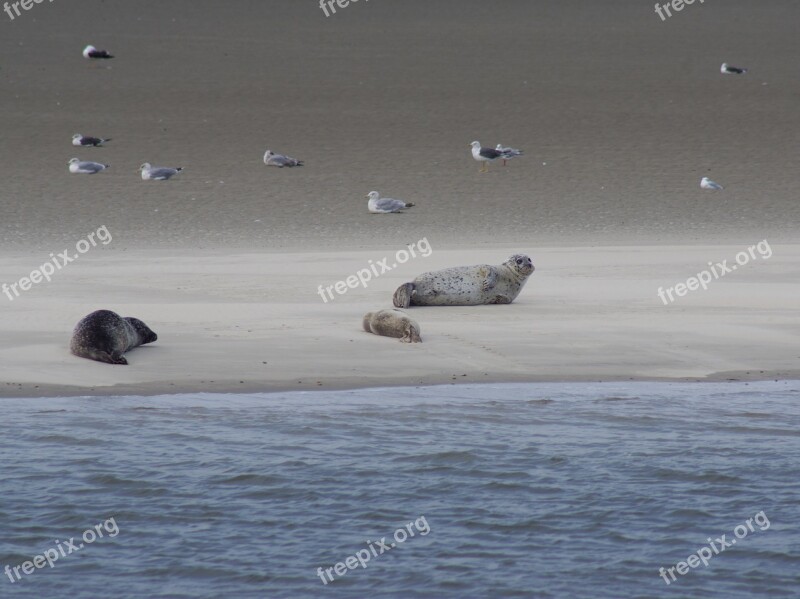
[69,310,158,364]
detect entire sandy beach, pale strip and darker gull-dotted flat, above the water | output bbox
[0,0,800,396]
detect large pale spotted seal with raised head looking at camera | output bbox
[393,254,534,308]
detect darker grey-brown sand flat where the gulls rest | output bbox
[0,0,800,251]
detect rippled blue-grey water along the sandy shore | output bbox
[0,382,800,599]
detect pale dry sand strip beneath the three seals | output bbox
[0,240,800,396]
